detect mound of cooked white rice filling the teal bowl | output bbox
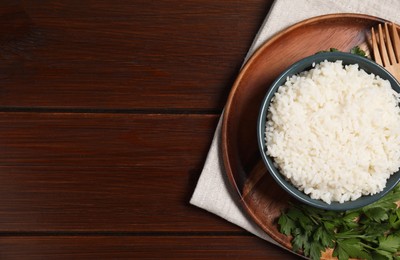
[265,61,400,204]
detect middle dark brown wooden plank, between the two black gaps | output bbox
[0,113,244,232]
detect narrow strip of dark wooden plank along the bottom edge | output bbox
[0,236,299,260]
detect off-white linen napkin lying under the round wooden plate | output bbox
[190,0,400,248]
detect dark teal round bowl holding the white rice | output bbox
[257,52,400,211]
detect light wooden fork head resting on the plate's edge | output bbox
[371,23,400,81]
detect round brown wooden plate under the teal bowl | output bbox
[222,14,385,254]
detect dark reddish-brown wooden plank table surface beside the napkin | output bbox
[0,0,295,259]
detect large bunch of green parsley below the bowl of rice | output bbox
[278,185,400,260]
